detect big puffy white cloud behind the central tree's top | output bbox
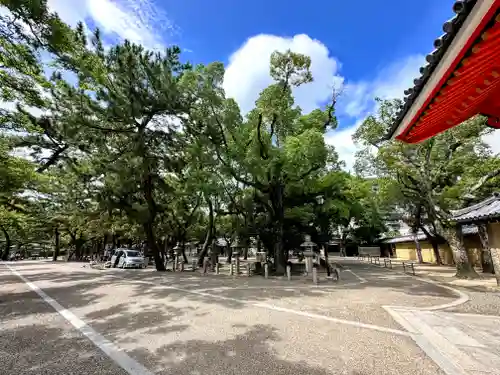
[224,34,342,112]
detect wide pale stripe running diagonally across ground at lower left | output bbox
[6,265,153,375]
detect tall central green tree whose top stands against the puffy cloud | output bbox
[184,51,336,273]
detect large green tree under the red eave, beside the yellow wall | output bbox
[353,100,500,278]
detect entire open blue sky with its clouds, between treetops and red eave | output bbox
[49,0,460,168]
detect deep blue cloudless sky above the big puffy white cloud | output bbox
[167,0,454,80]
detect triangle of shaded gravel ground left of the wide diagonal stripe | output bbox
[0,266,131,375]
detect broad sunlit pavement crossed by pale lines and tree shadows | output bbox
[0,261,498,375]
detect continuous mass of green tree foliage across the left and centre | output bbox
[0,5,394,271]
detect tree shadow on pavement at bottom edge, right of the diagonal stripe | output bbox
[130,325,368,375]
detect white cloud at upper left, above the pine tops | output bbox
[48,0,172,48]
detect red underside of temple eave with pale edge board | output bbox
[393,0,500,143]
